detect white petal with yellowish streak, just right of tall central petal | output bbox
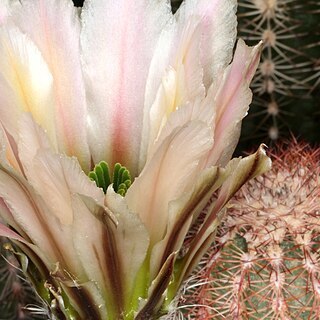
[140,17,205,165]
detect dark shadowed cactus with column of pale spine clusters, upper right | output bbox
[238,0,320,150]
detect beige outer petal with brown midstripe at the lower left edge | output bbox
[0,158,90,282]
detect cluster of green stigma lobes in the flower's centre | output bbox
[89,161,132,196]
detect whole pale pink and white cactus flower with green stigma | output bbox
[0,0,270,320]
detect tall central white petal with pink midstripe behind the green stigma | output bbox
[81,0,171,176]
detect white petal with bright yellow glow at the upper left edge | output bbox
[0,27,56,149]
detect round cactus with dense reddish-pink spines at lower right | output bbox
[172,142,320,320]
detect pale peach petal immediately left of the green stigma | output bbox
[18,116,103,225]
